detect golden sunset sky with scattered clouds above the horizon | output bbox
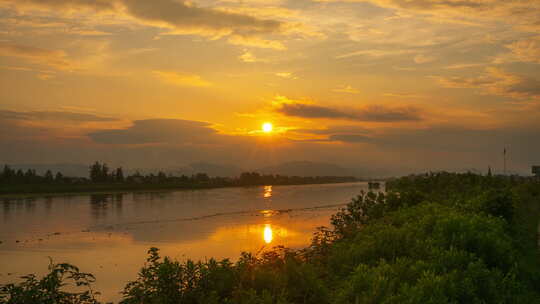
[0,0,540,174]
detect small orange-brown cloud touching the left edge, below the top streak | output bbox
[0,42,73,70]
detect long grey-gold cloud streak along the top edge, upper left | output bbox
[0,0,286,50]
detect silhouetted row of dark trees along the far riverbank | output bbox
[0,162,357,187]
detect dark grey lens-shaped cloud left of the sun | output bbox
[88,119,220,145]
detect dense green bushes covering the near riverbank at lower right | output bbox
[0,173,540,304]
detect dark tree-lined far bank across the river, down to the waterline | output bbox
[0,162,357,194]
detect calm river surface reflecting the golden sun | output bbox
[0,183,367,301]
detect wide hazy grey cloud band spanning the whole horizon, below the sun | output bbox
[0,111,540,174]
